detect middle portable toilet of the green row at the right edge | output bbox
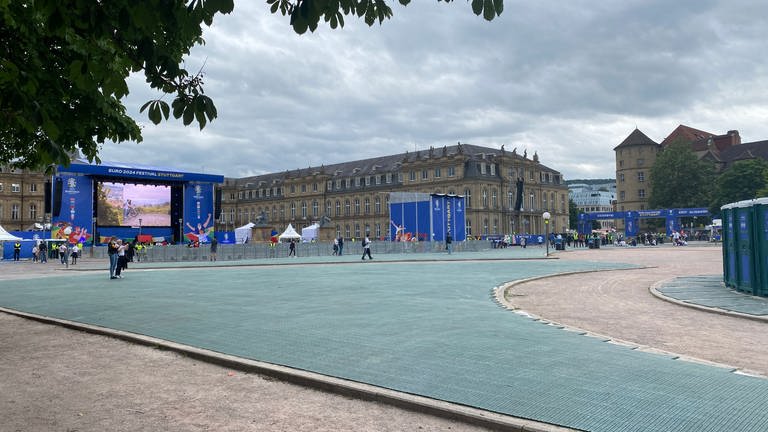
[734,200,757,294]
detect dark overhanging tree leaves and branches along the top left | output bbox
[0,0,503,168]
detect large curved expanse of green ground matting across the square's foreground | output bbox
[0,257,768,432]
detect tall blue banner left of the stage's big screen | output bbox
[51,175,93,244]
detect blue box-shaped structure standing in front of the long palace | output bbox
[389,192,467,241]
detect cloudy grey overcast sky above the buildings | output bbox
[102,0,768,179]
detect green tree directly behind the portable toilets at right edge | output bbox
[710,159,768,214]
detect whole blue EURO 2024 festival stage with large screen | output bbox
[50,159,224,245]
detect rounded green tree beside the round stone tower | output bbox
[648,140,714,208]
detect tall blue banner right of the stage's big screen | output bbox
[183,183,214,243]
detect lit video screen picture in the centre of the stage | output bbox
[96,182,171,227]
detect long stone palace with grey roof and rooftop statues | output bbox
[216,143,568,241]
